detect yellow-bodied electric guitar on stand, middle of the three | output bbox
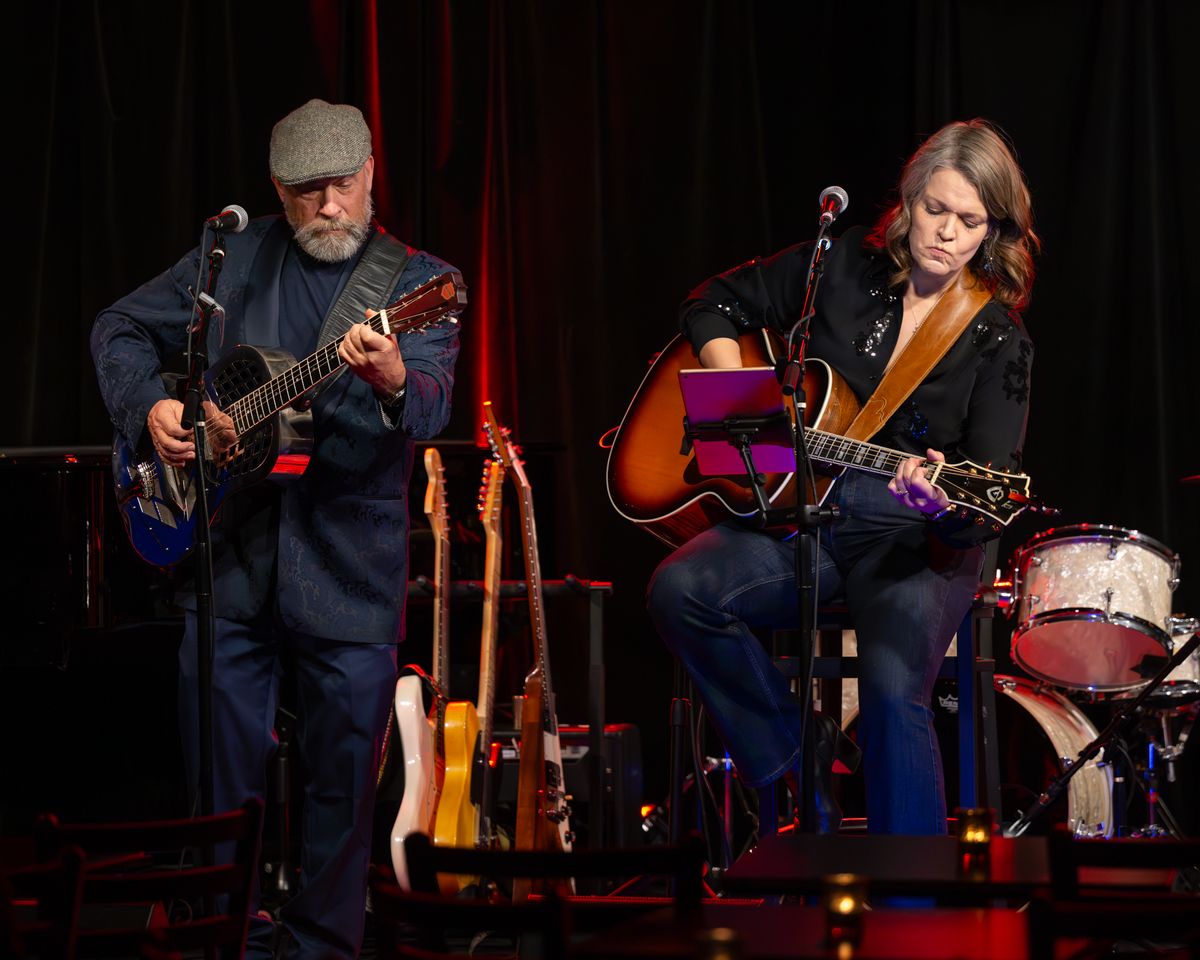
[433,446,504,895]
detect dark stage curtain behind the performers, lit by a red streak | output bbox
[11,0,1200,784]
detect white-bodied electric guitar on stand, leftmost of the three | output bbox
[391,446,451,890]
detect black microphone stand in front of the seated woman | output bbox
[777,214,834,833]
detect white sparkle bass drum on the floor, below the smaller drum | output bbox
[994,674,1112,836]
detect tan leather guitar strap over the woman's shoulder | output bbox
[844,264,991,440]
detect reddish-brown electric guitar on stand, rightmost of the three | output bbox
[484,401,574,902]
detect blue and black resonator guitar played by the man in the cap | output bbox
[113,271,467,566]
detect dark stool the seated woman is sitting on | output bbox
[760,540,1000,833]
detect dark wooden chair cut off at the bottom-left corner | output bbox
[0,847,83,960]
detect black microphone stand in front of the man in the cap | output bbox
[180,223,226,816]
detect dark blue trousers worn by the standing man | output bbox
[179,612,396,960]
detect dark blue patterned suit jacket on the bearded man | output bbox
[91,217,458,643]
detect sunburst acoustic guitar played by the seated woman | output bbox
[607,331,1032,547]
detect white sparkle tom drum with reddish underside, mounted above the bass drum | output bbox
[1012,523,1180,692]
